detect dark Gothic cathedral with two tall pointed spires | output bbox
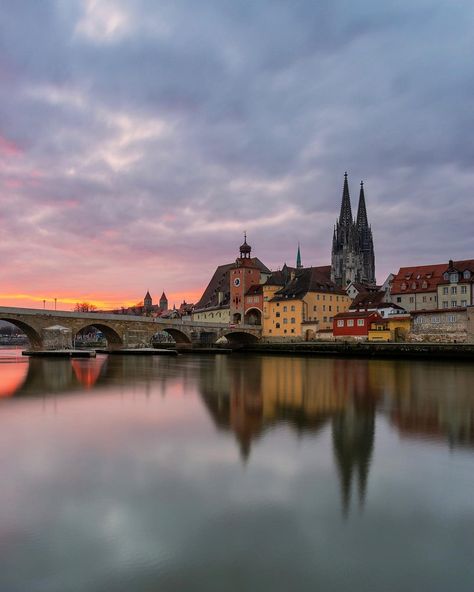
[331,173,375,289]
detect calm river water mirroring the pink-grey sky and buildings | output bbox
[0,351,474,592]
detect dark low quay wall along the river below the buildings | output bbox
[243,341,474,360]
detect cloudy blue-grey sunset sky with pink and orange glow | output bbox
[0,0,474,310]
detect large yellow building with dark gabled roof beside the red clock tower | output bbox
[263,266,351,340]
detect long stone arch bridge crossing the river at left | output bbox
[0,306,261,349]
